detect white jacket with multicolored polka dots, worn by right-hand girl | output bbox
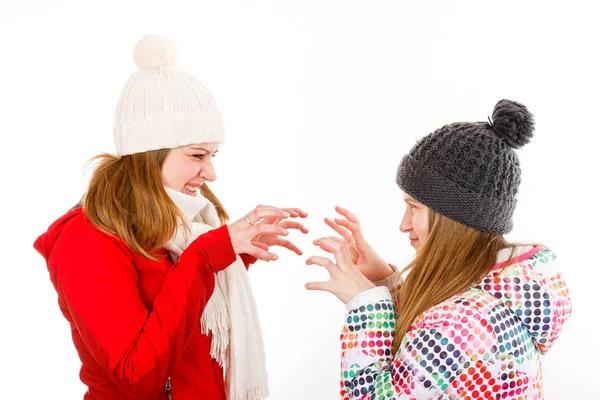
[341,246,571,400]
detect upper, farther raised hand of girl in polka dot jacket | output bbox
[324,207,394,281]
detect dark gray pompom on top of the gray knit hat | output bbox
[490,99,535,149]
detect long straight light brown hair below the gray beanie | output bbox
[393,209,516,354]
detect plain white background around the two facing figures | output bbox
[0,0,600,400]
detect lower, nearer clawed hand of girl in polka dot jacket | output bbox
[305,237,375,303]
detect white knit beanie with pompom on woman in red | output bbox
[114,34,225,156]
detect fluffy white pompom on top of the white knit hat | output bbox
[133,34,177,70]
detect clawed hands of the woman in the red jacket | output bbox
[227,205,308,261]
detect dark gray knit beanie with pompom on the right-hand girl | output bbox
[396,100,534,234]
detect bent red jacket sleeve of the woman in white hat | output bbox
[57,226,235,398]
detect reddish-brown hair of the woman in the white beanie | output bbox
[83,149,229,260]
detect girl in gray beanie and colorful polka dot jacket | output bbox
[307,100,571,400]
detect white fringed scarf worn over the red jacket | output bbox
[165,187,269,400]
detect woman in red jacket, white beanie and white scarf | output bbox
[34,35,307,400]
